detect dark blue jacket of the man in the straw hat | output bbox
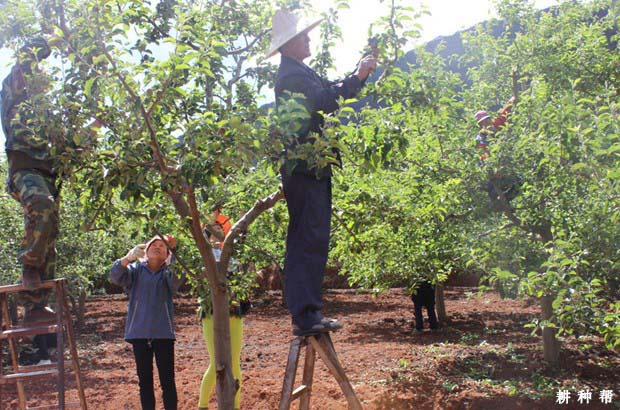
[275,56,364,176]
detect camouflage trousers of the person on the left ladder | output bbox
[8,169,59,310]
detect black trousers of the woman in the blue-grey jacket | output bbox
[129,339,177,410]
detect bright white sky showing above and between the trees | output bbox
[0,0,559,147]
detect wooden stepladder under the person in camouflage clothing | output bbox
[0,278,86,410]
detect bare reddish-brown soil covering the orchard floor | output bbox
[0,288,620,410]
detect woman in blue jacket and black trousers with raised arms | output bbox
[110,235,182,410]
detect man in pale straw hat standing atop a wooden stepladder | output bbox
[267,10,377,336]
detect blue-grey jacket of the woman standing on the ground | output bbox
[110,259,183,340]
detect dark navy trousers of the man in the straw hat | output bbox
[282,174,332,329]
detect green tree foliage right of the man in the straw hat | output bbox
[332,1,620,347]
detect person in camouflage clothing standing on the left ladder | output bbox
[1,38,59,322]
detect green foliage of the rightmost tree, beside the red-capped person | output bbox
[466,2,620,347]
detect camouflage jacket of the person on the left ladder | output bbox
[1,64,52,161]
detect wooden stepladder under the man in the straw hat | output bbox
[279,333,362,410]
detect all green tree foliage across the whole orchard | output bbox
[0,0,620,388]
